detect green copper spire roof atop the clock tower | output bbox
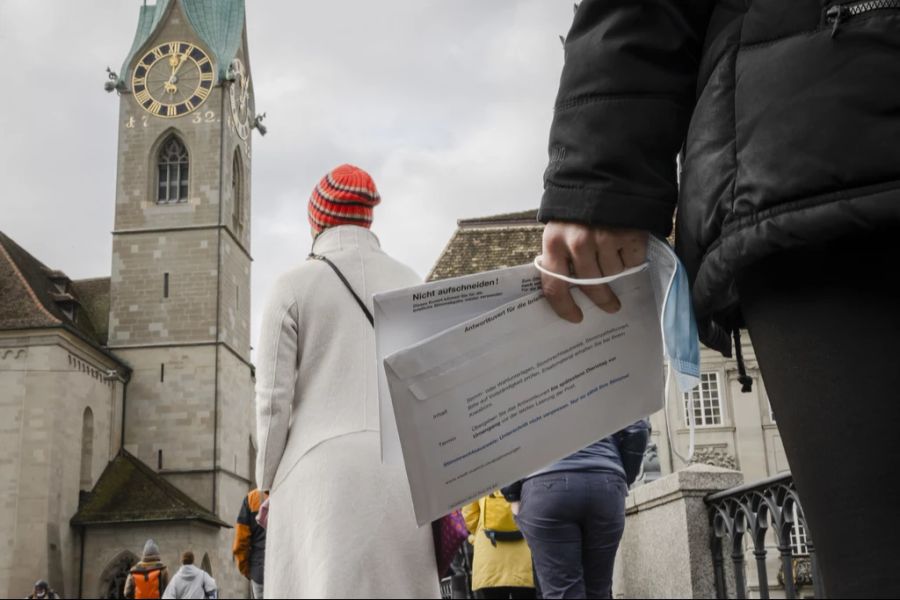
[117,0,244,90]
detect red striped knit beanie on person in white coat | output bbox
[309,165,381,234]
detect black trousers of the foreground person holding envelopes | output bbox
[738,231,900,598]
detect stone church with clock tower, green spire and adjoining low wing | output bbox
[0,0,256,597]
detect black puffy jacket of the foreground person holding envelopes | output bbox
[539,0,900,354]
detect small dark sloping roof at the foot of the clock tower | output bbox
[71,450,231,528]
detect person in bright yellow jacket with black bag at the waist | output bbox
[463,491,535,599]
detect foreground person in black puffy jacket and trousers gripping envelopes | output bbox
[538,0,900,598]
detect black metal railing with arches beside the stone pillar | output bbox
[706,473,825,598]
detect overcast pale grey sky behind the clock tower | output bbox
[0,0,572,354]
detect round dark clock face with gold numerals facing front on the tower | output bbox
[131,42,215,118]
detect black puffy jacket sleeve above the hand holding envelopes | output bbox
[538,0,713,236]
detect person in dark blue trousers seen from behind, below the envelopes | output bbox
[503,419,650,598]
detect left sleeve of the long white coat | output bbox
[256,276,299,491]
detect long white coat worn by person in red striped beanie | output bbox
[256,225,440,598]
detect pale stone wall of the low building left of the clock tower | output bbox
[0,330,122,597]
